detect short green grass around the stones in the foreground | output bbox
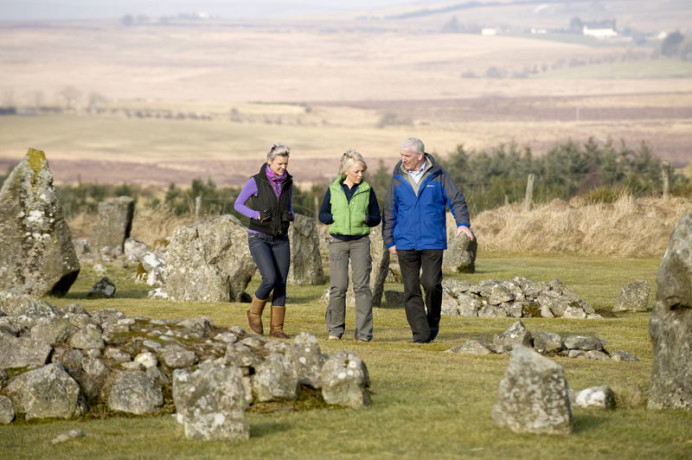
[0,254,692,459]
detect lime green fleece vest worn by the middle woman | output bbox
[329,175,370,235]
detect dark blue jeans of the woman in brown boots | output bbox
[248,233,291,306]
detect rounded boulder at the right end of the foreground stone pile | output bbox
[321,351,372,409]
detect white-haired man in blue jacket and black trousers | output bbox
[382,137,474,343]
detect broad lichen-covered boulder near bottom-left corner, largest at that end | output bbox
[5,363,86,420]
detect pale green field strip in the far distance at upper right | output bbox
[531,59,692,80]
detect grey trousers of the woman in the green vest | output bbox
[325,236,372,340]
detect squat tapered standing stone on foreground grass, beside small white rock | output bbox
[492,345,573,434]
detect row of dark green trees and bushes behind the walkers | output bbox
[0,139,692,218]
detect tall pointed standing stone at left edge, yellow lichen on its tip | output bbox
[0,149,79,297]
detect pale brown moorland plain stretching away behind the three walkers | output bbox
[0,2,692,186]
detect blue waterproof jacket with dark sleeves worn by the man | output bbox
[382,153,470,251]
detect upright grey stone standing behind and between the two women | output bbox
[288,214,325,285]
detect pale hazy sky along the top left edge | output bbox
[0,0,428,21]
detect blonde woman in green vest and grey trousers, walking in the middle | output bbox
[319,150,380,342]
